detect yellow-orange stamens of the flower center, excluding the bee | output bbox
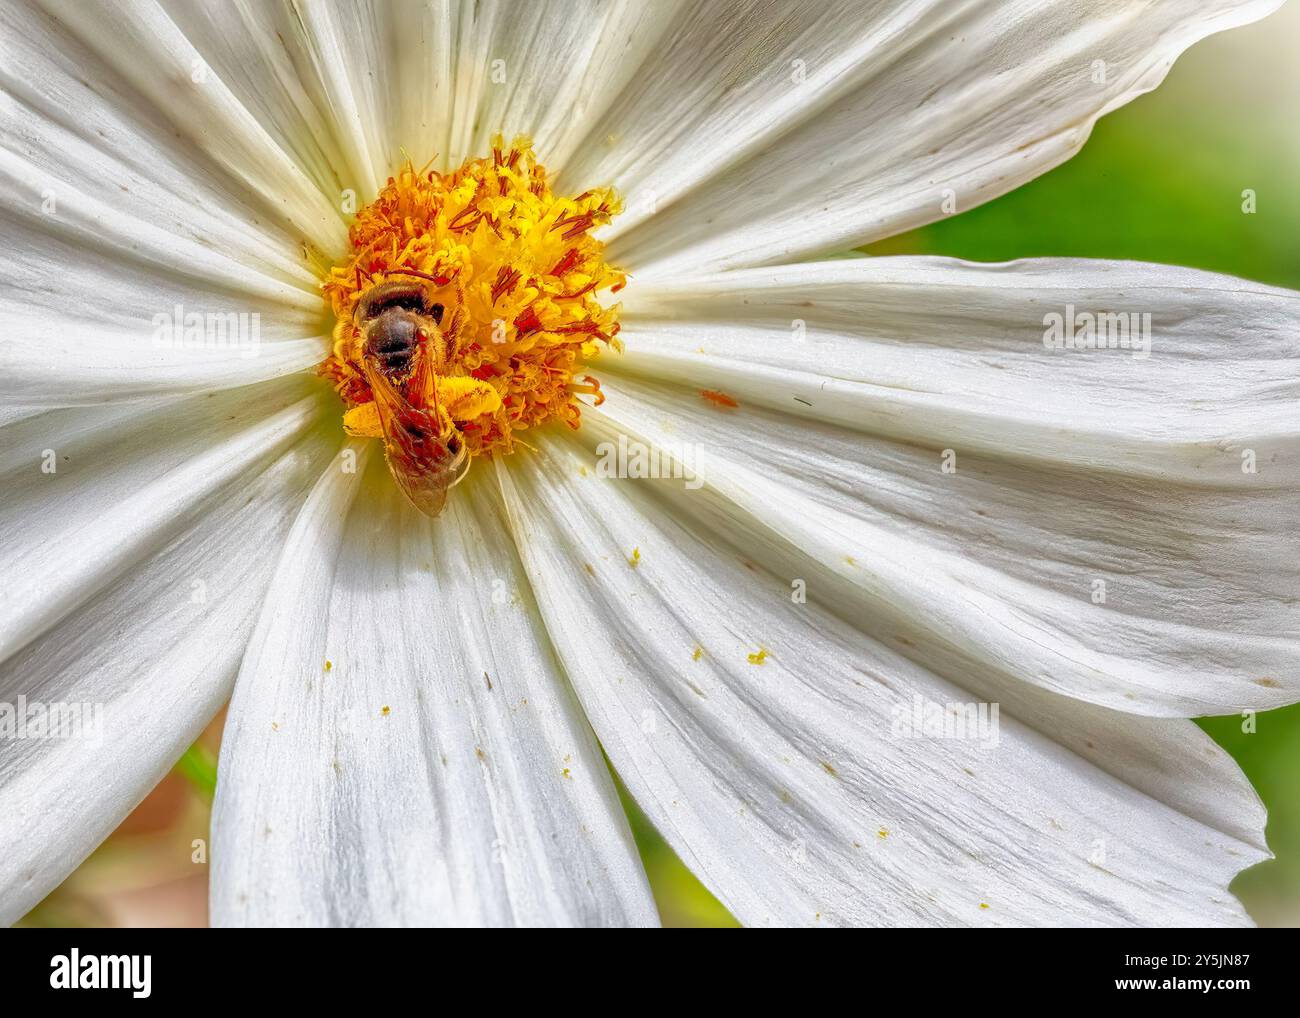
[320,135,627,455]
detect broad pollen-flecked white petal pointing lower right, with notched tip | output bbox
[499,429,1265,926]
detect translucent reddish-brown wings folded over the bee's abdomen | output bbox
[365,365,469,516]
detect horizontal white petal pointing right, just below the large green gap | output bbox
[610,257,1300,490]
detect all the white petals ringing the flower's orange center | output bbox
[0,0,1300,926]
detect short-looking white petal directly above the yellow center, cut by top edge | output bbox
[291,0,680,180]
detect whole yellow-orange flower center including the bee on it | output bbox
[320,135,627,515]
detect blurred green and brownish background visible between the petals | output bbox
[25,4,1300,926]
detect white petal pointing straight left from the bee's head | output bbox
[0,226,329,407]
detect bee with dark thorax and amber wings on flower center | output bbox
[352,272,469,517]
